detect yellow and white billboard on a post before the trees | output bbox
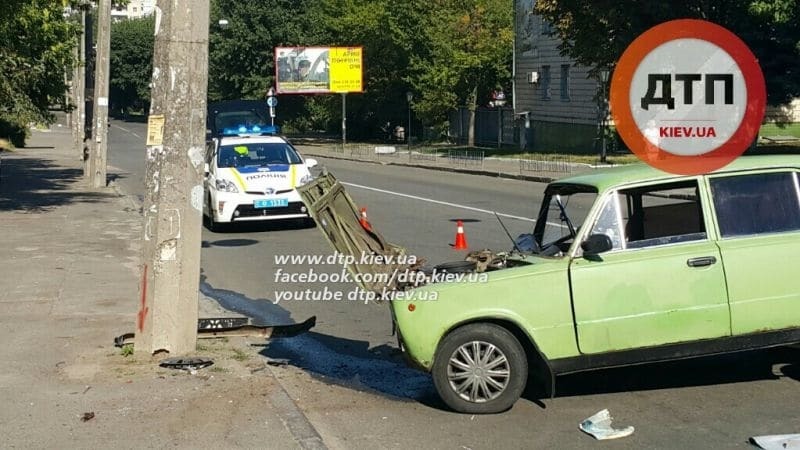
[275,47,364,94]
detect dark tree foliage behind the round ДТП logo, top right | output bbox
[534,0,800,104]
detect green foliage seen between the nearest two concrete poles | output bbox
[109,15,155,112]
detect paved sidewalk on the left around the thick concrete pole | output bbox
[0,121,312,448]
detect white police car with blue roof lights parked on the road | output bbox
[203,125,317,231]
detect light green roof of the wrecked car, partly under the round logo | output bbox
[554,155,800,192]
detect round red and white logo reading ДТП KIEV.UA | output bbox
[610,19,766,174]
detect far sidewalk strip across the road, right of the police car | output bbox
[292,139,595,183]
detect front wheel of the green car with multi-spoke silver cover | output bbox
[432,323,528,414]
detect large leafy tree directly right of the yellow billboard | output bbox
[310,0,513,142]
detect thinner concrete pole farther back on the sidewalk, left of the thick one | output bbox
[89,0,111,188]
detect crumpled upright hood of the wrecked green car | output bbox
[297,169,415,294]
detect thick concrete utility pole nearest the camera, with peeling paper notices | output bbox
[134,0,209,355]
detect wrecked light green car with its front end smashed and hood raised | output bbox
[301,155,800,413]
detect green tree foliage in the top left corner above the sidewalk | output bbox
[0,0,79,140]
